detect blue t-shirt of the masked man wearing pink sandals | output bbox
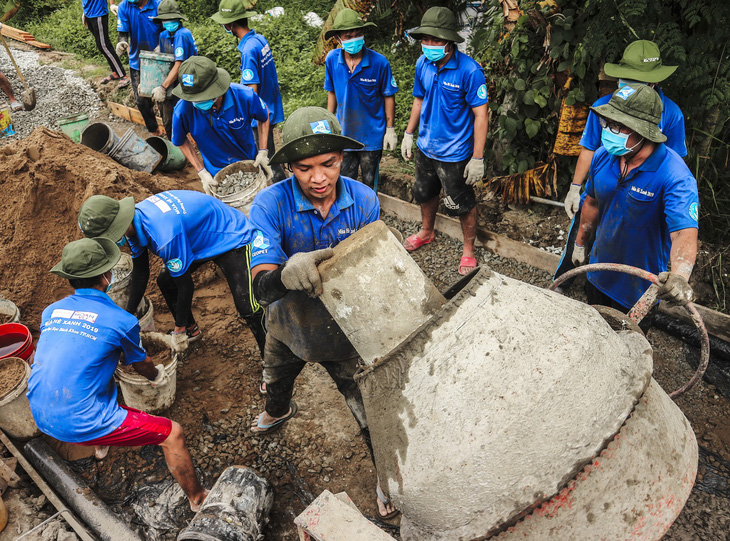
[413,51,488,162]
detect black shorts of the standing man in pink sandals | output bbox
[413,148,477,216]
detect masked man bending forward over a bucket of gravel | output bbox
[172,56,271,194]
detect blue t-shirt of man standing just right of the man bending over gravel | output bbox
[238,30,284,126]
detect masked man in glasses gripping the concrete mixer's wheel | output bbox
[573,83,699,320]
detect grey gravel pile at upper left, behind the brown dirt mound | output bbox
[0,47,102,146]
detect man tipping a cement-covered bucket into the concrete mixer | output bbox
[251,107,394,517]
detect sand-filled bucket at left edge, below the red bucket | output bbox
[0,357,41,440]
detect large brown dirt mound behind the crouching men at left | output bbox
[0,128,180,333]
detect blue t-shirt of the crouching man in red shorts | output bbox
[28,289,147,443]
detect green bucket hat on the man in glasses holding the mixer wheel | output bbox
[591,83,667,143]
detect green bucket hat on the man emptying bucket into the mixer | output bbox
[269,107,365,163]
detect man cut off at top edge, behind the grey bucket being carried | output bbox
[116,0,162,135]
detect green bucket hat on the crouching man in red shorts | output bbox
[51,237,122,280]
